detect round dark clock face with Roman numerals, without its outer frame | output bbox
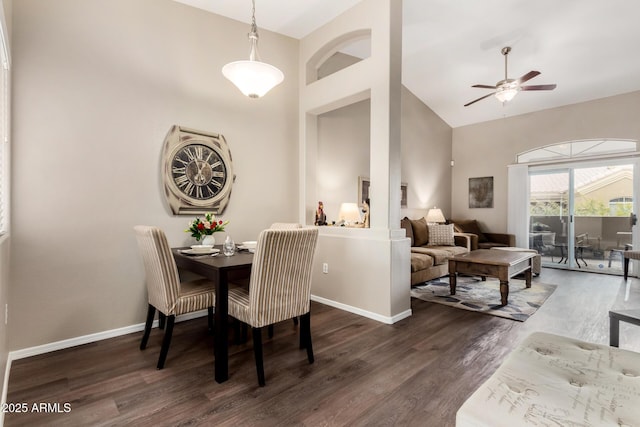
[171,144,227,200]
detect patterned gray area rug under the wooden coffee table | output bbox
[411,276,557,322]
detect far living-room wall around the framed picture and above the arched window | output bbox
[452,92,640,232]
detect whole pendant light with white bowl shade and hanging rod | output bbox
[222,0,284,98]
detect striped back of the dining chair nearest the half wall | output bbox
[249,228,318,327]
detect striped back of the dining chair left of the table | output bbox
[133,225,180,316]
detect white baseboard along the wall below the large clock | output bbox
[5,310,207,362]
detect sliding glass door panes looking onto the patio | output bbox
[529,160,637,274]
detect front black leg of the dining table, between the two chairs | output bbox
[213,271,229,383]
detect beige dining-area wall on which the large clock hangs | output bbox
[9,0,298,350]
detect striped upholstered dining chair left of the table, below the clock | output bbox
[134,225,216,369]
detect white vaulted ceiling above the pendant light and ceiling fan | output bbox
[176,0,640,127]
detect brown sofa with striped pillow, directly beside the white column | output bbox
[401,217,471,286]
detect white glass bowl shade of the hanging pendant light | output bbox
[222,60,284,98]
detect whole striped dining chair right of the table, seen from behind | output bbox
[229,228,318,387]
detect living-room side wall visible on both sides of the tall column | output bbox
[317,86,452,221]
